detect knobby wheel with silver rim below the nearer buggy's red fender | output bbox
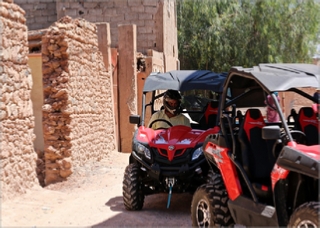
[191,171,233,227]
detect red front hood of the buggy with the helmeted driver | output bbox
[137,125,219,161]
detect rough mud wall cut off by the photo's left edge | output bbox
[0,0,39,199]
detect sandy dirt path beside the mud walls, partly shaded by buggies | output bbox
[0,152,192,227]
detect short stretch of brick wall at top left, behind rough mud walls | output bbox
[14,0,57,30]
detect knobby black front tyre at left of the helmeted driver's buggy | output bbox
[122,163,144,211]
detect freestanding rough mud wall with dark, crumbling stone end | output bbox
[42,16,115,185]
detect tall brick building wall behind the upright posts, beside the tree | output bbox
[57,0,178,58]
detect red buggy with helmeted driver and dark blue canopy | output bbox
[123,70,226,210]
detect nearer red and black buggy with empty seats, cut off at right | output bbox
[191,64,320,227]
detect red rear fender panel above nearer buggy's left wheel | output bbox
[205,142,242,200]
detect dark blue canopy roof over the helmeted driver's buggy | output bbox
[143,70,227,92]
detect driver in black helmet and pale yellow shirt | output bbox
[148,89,190,129]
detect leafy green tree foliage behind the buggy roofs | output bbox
[177,0,320,72]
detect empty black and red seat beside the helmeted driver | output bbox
[199,101,219,130]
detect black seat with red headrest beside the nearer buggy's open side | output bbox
[238,109,275,198]
